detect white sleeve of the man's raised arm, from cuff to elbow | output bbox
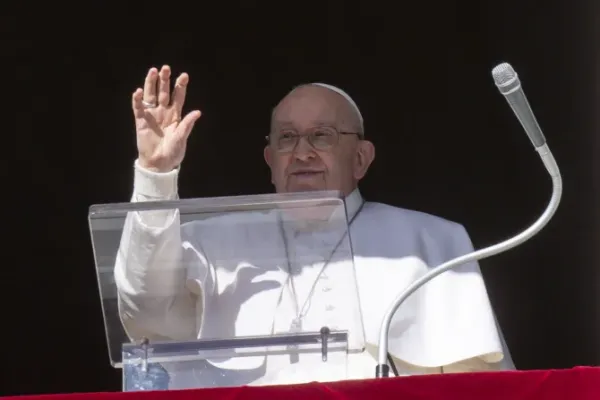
[114,161,197,340]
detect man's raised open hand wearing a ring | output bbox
[131,65,201,172]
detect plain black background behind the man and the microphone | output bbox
[0,0,600,395]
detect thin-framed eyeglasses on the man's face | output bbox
[266,126,363,153]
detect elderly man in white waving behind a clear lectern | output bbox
[115,66,513,387]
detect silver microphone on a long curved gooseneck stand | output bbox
[375,63,562,378]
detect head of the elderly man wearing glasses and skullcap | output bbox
[265,86,372,195]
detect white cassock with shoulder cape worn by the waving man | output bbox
[115,164,514,388]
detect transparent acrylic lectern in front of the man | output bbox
[89,192,365,391]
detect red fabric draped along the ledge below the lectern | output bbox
[4,367,600,400]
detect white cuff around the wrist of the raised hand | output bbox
[133,160,179,199]
